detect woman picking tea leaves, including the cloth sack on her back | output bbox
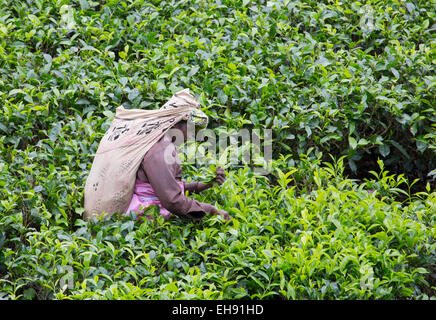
[84,89,230,220]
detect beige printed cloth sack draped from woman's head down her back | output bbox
[84,89,207,219]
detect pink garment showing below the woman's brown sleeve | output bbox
[126,179,185,220]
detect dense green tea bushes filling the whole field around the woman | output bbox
[0,0,436,299]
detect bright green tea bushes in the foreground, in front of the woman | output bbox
[0,157,436,299]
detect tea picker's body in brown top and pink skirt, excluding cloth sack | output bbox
[127,116,230,221]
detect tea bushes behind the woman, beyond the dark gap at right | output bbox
[0,0,436,179]
